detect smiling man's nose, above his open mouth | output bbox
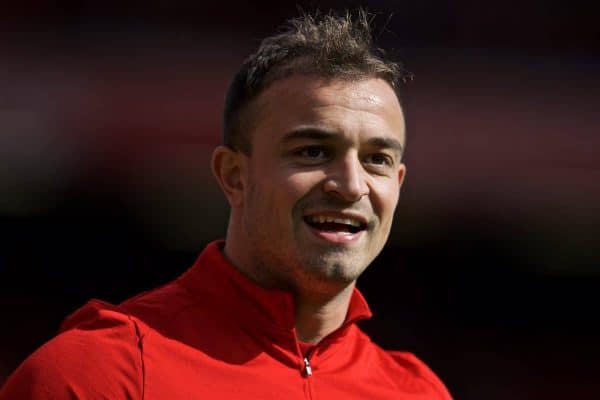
[323,155,369,202]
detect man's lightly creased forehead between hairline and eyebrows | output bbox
[248,75,404,143]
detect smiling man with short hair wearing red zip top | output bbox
[0,13,450,400]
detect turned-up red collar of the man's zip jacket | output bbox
[178,240,372,345]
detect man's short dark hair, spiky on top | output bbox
[223,9,412,154]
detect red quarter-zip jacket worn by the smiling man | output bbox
[0,242,450,400]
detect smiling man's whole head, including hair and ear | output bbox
[212,13,405,293]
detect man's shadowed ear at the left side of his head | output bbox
[210,146,246,208]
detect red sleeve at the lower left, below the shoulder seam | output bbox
[0,309,143,400]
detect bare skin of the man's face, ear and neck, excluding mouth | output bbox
[212,75,406,343]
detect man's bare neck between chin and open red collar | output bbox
[295,283,354,344]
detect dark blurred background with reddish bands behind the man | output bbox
[0,0,600,400]
